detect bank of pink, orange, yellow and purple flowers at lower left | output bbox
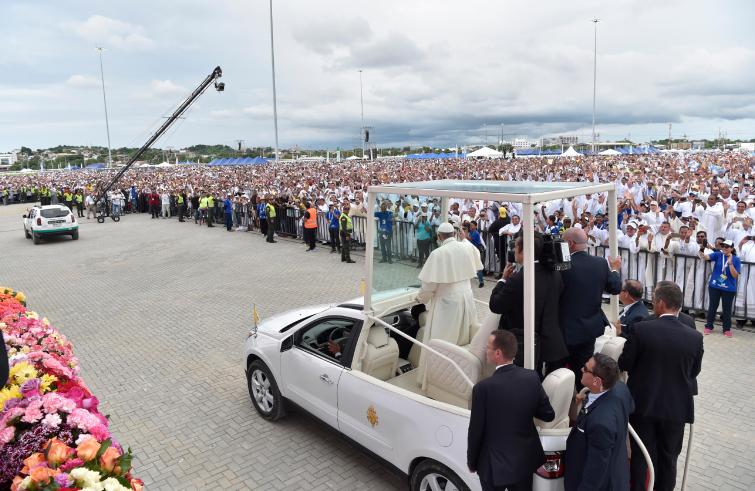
[0,287,143,491]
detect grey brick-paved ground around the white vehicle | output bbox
[0,202,755,490]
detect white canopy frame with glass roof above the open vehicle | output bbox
[364,179,619,369]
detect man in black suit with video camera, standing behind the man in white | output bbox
[489,234,569,375]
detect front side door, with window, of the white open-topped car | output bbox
[281,317,361,428]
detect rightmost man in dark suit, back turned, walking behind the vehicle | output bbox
[619,281,703,491]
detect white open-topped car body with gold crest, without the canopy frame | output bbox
[244,288,574,491]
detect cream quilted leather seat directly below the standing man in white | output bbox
[425,339,482,409]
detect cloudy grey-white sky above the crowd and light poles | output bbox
[0,0,755,151]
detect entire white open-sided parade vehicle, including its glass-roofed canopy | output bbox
[244,180,653,491]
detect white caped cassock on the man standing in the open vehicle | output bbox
[417,237,482,346]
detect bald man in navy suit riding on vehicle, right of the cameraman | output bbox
[559,228,621,388]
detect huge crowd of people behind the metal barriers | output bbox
[0,152,755,322]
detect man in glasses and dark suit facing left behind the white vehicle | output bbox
[564,353,634,491]
